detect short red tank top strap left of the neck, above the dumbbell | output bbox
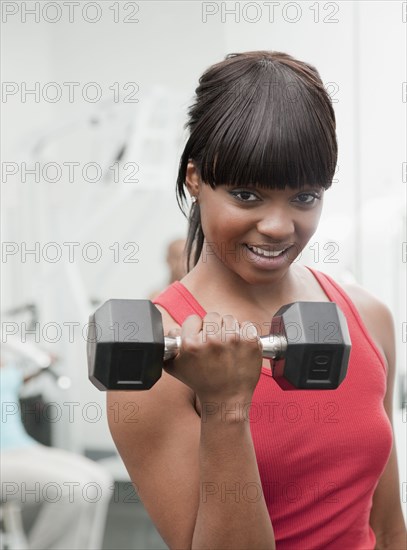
[153,281,206,325]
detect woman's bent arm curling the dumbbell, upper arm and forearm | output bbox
[108,308,275,550]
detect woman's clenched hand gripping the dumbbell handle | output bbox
[165,313,262,402]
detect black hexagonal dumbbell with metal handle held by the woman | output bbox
[87,300,351,390]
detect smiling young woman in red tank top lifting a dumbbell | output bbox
[108,51,405,550]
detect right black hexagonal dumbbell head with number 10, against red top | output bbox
[272,302,351,390]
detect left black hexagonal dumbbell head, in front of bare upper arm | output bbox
[87,300,164,390]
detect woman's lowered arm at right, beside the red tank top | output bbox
[344,285,407,550]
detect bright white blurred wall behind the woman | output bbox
[2,1,406,496]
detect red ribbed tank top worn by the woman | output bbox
[154,268,393,550]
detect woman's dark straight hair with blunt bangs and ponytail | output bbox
[177,51,338,269]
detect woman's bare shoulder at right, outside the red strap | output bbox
[341,283,395,374]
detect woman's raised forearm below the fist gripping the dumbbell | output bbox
[192,403,275,550]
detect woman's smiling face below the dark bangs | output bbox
[190,164,324,284]
